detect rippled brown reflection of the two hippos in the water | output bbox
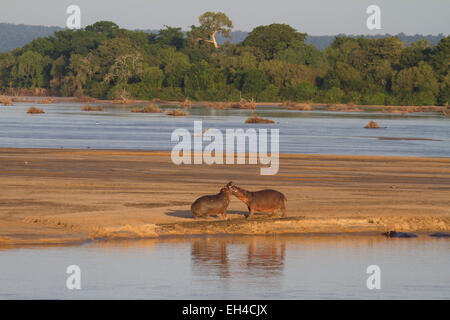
[191,238,286,277]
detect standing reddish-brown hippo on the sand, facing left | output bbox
[230,185,287,218]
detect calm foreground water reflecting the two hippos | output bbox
[0,235,450,299]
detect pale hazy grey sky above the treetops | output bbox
[0,0,450,35]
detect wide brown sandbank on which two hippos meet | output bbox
[0,149,450,247]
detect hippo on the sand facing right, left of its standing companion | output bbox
[191,181,233,219]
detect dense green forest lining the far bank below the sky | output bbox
[0,12,450,105]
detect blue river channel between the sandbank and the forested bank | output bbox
[0,103,450,157]
